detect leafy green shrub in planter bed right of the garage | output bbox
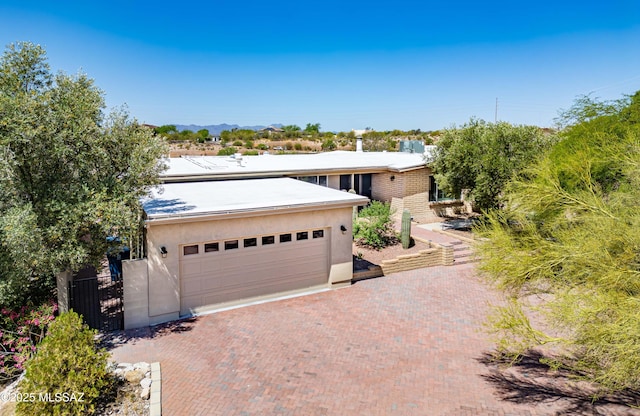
[353,201,400,250]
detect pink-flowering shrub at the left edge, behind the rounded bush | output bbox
[0,302,58,384]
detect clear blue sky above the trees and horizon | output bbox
[0,0,640,131]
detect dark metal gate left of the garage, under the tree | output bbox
[69,274,124,332]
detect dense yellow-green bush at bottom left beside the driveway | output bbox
[16,311,115,415]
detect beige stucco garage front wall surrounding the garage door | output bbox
[136,207,353,326]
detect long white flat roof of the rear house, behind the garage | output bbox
[161,146,435,179]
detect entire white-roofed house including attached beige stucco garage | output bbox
[59,146,460,328]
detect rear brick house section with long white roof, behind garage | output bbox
[162,146,462,222]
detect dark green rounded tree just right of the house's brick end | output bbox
[432,119,555,210]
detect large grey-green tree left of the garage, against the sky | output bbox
[0,43,165,306]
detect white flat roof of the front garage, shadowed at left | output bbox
[143,178,369,221]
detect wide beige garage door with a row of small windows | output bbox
[180,229,330,315]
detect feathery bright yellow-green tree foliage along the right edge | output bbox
[478,92,640,389]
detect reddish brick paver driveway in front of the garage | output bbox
[111,264,637,416]
